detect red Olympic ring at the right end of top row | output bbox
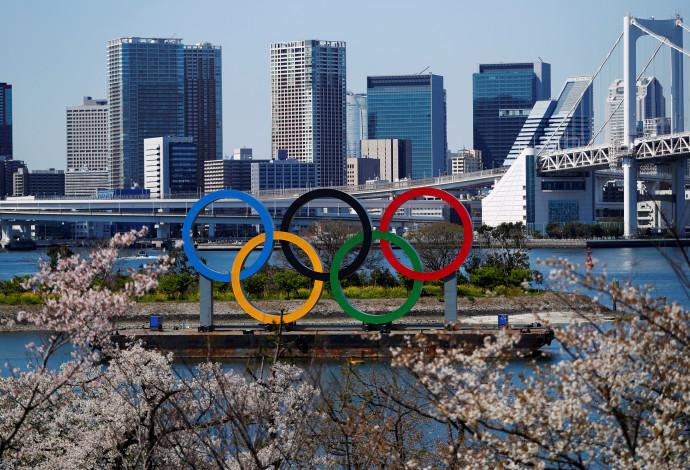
[379,188,473,281]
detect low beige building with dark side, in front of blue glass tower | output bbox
[357,139,414,184]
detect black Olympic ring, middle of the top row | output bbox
[280,188,372,281]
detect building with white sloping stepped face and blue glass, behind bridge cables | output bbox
[502,77,594,166]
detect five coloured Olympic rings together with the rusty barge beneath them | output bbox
[116,187,553,358]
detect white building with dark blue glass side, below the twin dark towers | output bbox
[144,137,197,199]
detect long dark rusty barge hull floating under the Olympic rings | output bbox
[114,327,554,359]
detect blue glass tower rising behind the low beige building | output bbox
[367,74,447,179]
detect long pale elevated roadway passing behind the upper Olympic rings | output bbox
[0,168,506,233]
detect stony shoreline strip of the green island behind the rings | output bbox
[0,291,629,332]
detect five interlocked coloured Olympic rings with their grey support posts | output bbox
[182,188,472,331]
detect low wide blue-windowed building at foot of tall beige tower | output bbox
[251,158,316,192]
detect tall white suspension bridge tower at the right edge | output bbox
[623,14,686,237]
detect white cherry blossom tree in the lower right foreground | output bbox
[394,261,690,469]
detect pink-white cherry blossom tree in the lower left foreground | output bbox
[0,232,322,469]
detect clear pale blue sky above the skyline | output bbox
[0,0,690,169]
